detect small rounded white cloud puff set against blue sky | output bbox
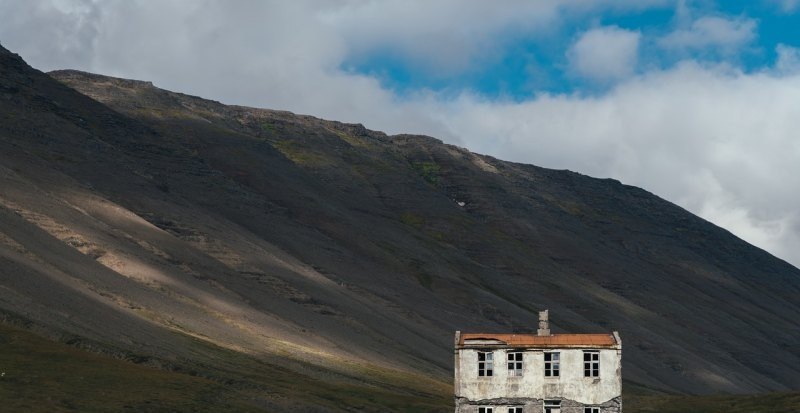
[567,26,641,82]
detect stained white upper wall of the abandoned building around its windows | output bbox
[455,349,622,406]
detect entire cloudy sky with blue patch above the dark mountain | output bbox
[0,0,800,266]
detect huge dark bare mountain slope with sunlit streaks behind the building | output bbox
[0,41,800,411]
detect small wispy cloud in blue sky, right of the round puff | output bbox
[659,16,757,54]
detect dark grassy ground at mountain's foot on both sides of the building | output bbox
[0,323,800,413]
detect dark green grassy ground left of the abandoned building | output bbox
[0,323,452,413]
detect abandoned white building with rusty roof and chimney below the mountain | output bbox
[455,311,622,413]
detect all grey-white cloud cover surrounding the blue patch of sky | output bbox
[0,0,800,265]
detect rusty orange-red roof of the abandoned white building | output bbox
[458,333,617,347]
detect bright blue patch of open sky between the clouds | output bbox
[341,0,800,100]
